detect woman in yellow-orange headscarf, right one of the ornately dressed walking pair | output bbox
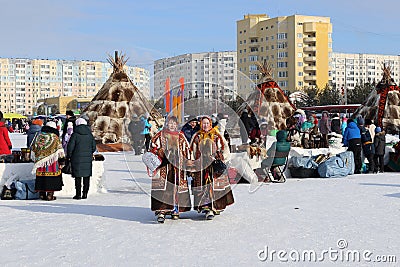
[190,117,234,220]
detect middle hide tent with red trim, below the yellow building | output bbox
[238,62,296,130]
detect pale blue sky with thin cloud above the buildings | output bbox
[0,0,400,68]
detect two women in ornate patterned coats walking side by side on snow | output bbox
[150,116,234,223]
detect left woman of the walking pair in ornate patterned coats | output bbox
[151,116,191,223]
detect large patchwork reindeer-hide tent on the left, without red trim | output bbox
[83,52,162,149]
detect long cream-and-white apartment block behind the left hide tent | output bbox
[0,58,150,115]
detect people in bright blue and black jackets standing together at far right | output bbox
[343,117,386,173]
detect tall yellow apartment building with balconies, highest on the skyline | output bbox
[237,14,332,95]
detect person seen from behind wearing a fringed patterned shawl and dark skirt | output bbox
[31,121,65,201]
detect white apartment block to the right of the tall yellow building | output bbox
[331,52,400,89]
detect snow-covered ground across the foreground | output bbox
[0,134,400,266]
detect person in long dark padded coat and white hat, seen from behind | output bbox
[67,118,96,199]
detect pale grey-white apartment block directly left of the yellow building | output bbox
[154,51,237,101]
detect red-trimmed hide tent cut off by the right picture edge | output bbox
[352,65,400,133]
